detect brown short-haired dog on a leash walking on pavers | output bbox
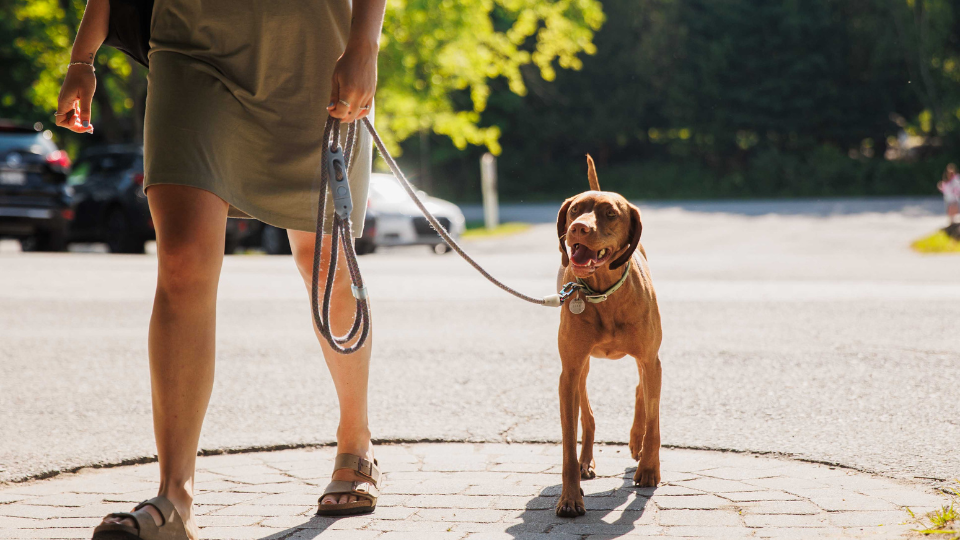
[557,156,662,517]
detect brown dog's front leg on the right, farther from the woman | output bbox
[630,356,662,487]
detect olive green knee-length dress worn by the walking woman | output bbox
[144,0,372,237]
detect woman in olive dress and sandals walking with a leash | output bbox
[57,0,385,540]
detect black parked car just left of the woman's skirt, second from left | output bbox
[67,145,156,253]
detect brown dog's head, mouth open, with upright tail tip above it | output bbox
[557,156,643,278]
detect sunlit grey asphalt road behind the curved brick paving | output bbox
[0,200,960,486]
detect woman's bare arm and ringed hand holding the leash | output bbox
[327,0,387,123]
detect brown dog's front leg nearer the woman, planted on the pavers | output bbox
[557,350,589,517]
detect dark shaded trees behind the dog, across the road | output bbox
[420,0,960,199]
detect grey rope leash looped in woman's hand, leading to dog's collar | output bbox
[312,116,576,354]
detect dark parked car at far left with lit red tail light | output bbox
[0,121,73,251]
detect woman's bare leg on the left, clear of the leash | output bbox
[99,185,228,539]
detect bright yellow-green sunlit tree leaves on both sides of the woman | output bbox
[0,0,603,152]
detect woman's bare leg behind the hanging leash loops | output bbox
[287,231,373,504]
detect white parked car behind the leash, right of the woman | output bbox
[367,173,466,253]
